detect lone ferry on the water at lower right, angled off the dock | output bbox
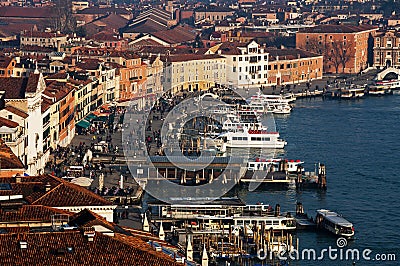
[315,209,354,238]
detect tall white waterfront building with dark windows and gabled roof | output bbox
[207,41,269,88]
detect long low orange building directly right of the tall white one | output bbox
[266,48,323,85]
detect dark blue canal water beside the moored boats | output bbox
[239,95,400,265]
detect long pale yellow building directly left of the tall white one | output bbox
[161,54,226,93]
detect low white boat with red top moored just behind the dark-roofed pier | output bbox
[247,158,304,173]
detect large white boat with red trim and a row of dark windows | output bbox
[217,128,287,149]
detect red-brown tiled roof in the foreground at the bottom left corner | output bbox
[0,230,181,266]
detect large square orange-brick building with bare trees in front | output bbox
[296,25,378,74]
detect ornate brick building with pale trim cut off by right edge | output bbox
[373,30,400,68]
